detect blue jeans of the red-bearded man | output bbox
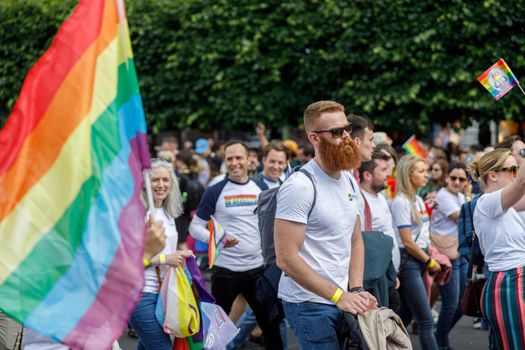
[283,301,345,350]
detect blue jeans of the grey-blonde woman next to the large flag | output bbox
[129,293,173,350]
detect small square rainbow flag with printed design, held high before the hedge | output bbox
[478,58,519,100]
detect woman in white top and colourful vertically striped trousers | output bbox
[471,149,525,349]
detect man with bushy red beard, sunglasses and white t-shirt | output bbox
[274,101,377,350]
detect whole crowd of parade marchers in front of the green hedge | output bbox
[2,101,525,350]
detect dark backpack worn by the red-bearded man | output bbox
[255,169,317,266]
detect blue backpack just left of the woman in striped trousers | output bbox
[458,194,485,269]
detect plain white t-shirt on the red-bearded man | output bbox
[275,160,359,304]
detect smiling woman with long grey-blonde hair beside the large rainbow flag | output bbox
[130,158,192,350]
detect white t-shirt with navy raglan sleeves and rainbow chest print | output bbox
[190,178,268,271]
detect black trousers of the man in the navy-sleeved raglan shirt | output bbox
[211,266,283,350]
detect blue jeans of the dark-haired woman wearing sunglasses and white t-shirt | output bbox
[436,257,468,347]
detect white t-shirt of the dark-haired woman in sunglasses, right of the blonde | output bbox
[430,187,465,236]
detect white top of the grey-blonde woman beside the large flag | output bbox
[143,208,178,293]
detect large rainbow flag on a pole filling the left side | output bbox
[0,0,150,350]
